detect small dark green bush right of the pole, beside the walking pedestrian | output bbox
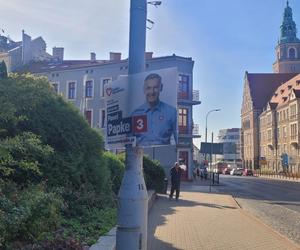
[143,156,166,193]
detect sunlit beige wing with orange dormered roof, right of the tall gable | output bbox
[259,74,300,173]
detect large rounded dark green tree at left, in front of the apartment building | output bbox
[0,74,111,206]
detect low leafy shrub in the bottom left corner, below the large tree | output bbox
[0,181,63,249]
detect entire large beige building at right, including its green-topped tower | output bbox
[241,1,300,171]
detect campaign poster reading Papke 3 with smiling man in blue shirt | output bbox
[105,68,178,148]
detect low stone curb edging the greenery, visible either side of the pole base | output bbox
[89,190,157,250]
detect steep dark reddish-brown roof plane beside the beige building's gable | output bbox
[246,73,297,109]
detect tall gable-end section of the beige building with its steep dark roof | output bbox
[241,72,297,169]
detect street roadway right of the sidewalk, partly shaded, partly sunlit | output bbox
[214,175,300,246]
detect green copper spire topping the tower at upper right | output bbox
[280,1,300,43]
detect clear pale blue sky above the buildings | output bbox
[0,0,300,146]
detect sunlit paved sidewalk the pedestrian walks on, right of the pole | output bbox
[147,182,300,250]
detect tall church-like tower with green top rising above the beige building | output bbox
[273,1,300,73]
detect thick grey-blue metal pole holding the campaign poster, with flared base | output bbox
[116,0,148,250]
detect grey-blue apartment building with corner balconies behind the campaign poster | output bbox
[22,51,201,179]
